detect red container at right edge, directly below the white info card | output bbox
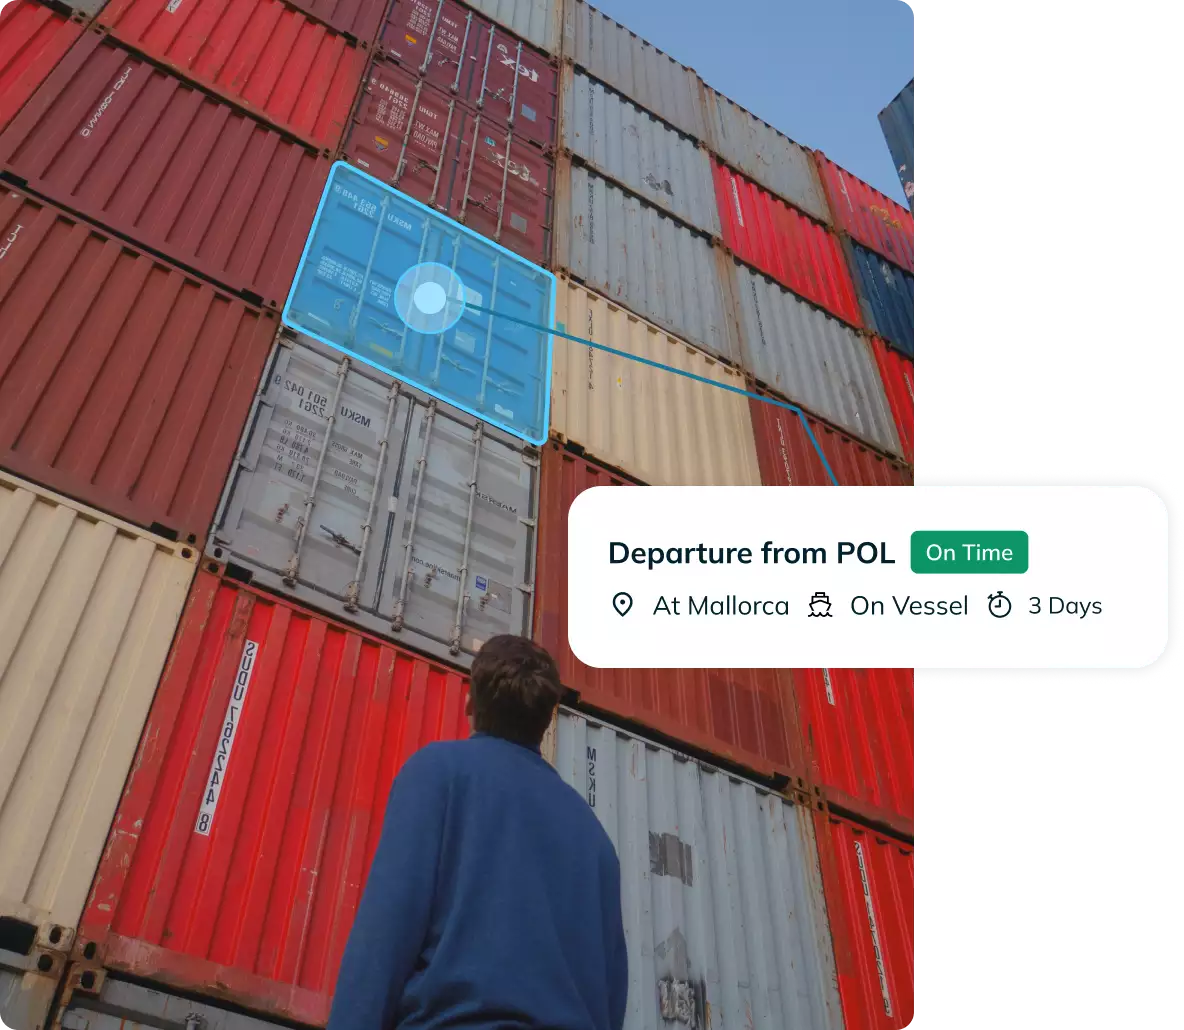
[793,669,913,837]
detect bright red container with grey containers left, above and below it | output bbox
[713,161,863,329]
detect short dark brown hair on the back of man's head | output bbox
[469,635,564,747]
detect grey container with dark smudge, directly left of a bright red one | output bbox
[564,65,720,237]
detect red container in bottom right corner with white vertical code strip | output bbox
[815,812,913,1030]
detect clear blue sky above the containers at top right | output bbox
[592,0,913,204]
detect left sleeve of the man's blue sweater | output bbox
[328,752,448,1030]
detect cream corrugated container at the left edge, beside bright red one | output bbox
[0,472,197,952]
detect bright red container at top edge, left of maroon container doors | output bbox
[96,0,369,152]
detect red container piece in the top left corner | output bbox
[0,0,84,130]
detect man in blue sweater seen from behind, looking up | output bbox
[328,636,629,1030]
